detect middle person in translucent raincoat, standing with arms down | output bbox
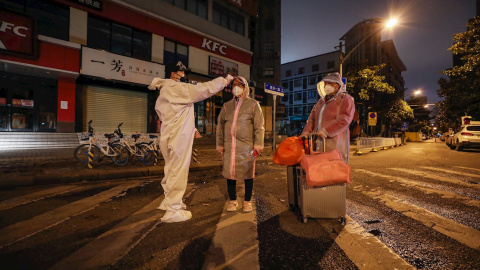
[217,77,265,212]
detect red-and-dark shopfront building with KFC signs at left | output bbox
[0,0,257,133]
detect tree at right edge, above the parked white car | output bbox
[437,16,480,130]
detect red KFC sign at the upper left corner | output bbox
[0,9,35,56]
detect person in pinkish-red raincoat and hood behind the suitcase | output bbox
[301,72,355,163]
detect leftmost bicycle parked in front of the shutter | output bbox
[74,120,129,168]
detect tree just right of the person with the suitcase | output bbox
[347,64,413,136]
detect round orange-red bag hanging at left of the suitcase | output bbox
[273,136,305,165]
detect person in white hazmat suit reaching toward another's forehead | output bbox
[148,62,233,223]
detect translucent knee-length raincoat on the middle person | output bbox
[217,97,265,180]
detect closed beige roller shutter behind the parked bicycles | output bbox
[84,85,148,133]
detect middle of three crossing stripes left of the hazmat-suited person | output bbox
[0,181,144,248]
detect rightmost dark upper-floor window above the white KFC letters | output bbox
[212,2,245,36]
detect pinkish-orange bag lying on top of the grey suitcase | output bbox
[300,136,351,188]
